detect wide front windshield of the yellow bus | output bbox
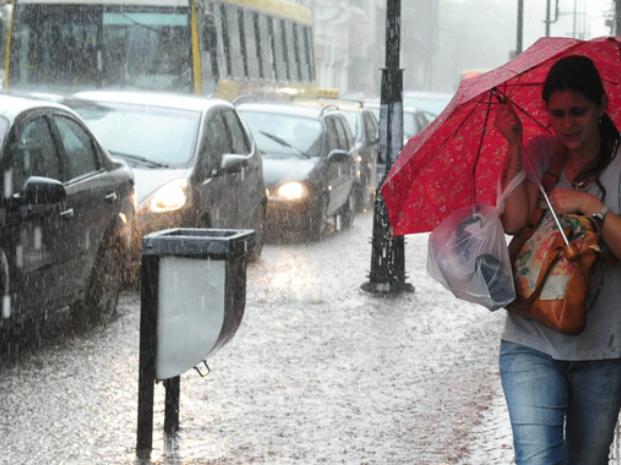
[10,2,192,93]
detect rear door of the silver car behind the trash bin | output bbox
[224,109,265,229]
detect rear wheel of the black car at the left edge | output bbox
[72,234,124,323]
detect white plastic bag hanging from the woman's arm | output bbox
[427,171,524,310]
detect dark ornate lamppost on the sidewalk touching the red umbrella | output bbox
[361,0,414,295]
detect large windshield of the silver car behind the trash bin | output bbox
[68,101,201,167]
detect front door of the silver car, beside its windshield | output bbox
[194,108,238,228]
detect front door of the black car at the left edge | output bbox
[0,111,66,315]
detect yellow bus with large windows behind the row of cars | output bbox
[0,0,317,100]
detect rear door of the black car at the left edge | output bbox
[50,113,118,295]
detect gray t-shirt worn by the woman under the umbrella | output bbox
[502,137,621,361]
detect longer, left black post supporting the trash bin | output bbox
[136,255,159,458]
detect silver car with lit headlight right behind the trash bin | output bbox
[66,91,267,268]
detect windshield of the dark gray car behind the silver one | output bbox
[240,110,322,157]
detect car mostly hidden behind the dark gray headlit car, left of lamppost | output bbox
[288,98,379,211]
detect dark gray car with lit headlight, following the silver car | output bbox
[238,103,356,241]
